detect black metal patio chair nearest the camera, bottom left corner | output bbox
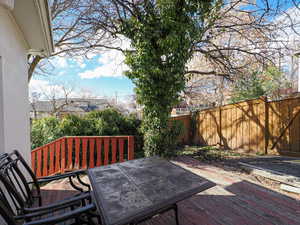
[0,169,100,225]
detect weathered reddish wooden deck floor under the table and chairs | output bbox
[42,157,300,225]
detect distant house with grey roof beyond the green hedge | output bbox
[30,98,110,119]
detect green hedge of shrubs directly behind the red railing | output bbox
[31,108,144,157]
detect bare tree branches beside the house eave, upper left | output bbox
[28,0,113,82]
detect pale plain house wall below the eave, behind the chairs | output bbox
[0,5,30,163]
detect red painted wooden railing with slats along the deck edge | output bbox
[31,136,134,177]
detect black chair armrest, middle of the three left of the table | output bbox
[21,192,91,214]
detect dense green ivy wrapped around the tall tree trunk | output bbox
[121,0,222,156]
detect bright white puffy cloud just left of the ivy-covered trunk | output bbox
[79,38,130,79]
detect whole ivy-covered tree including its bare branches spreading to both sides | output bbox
[85,0,297,155]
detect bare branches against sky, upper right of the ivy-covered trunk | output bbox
[187,0,300,79]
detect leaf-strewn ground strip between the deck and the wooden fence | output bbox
[179,146,300,200]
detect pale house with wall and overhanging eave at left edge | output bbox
[0,0,54,161]
